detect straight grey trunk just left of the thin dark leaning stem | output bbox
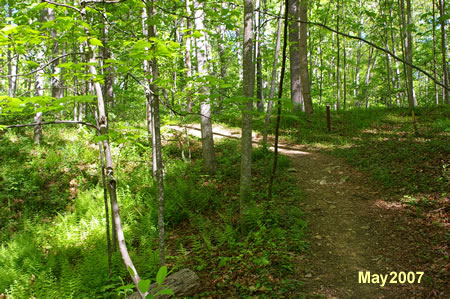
[239,0,255,234]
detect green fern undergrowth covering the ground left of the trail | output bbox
[0,120,306,298]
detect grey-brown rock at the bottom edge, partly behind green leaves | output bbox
[128,269,200,299]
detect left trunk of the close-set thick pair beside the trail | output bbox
[288,0,304,110]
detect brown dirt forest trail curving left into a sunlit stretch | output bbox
[171,125,448,299]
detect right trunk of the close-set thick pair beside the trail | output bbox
[298,0,313,114]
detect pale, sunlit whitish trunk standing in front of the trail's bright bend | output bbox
[194,1,216,175]
